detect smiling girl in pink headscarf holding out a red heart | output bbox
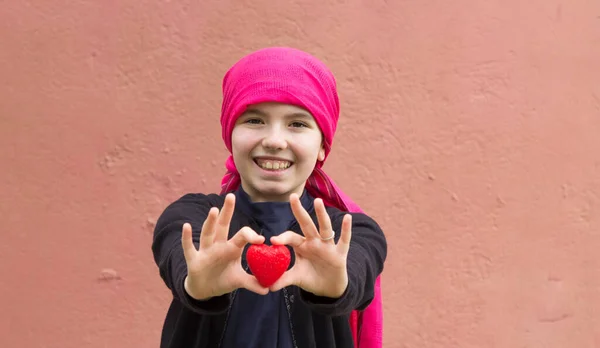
[152,47,387,348]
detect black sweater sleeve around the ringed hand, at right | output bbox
[300,213,387,316]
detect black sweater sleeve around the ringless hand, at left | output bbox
[152,194,230,314]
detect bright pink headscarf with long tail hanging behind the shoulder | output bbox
[221,47,383,348]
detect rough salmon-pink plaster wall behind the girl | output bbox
[0,0,600,348]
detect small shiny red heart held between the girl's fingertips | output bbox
[246,244,291,288]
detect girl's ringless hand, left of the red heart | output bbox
[181,194,269,300]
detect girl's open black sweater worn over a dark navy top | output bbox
[152,194,387,348]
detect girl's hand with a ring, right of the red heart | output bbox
[270,194,352,298]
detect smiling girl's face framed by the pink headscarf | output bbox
[231,103,325,202]
